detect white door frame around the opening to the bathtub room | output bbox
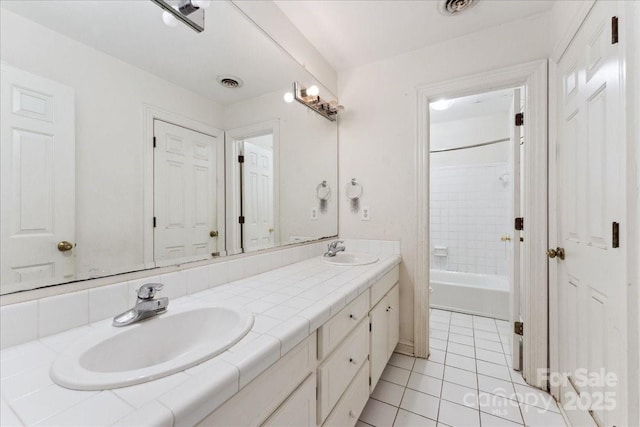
[414,59,548,389]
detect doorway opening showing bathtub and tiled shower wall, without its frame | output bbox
[429,87,525,370]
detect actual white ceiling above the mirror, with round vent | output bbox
[275,0,553,71]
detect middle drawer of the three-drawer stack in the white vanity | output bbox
[318,320,369,424]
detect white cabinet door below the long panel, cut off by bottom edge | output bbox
[263,372,316,427]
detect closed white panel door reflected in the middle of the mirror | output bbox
[153,120,218,266]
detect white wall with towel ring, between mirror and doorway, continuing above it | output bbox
[338,15,550,343]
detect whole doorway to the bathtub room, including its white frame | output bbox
[414,61,548,388]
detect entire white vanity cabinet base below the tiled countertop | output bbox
[200,266,400,427]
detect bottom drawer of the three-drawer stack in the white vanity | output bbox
[323,362,369,427]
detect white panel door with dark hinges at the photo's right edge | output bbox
[550,1,624,426]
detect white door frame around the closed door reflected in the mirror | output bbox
[141,104,226,269]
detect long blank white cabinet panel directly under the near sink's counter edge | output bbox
[199,333,318,426]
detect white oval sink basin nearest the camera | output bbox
[51,307,253,390]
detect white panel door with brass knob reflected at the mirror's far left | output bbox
[0,64,75,292]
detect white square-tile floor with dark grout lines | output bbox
[357,309,565,427]
